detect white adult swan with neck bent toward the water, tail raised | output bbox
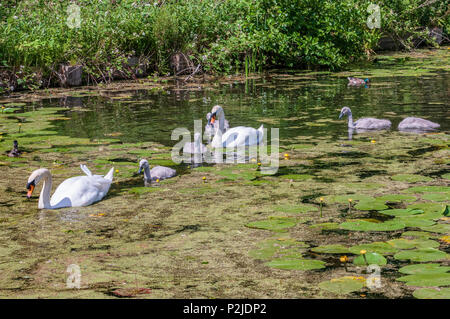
[27,165,114,209]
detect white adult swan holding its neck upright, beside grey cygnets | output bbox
[211,105,264,148]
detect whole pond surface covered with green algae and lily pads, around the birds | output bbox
[0,50,450,298]
